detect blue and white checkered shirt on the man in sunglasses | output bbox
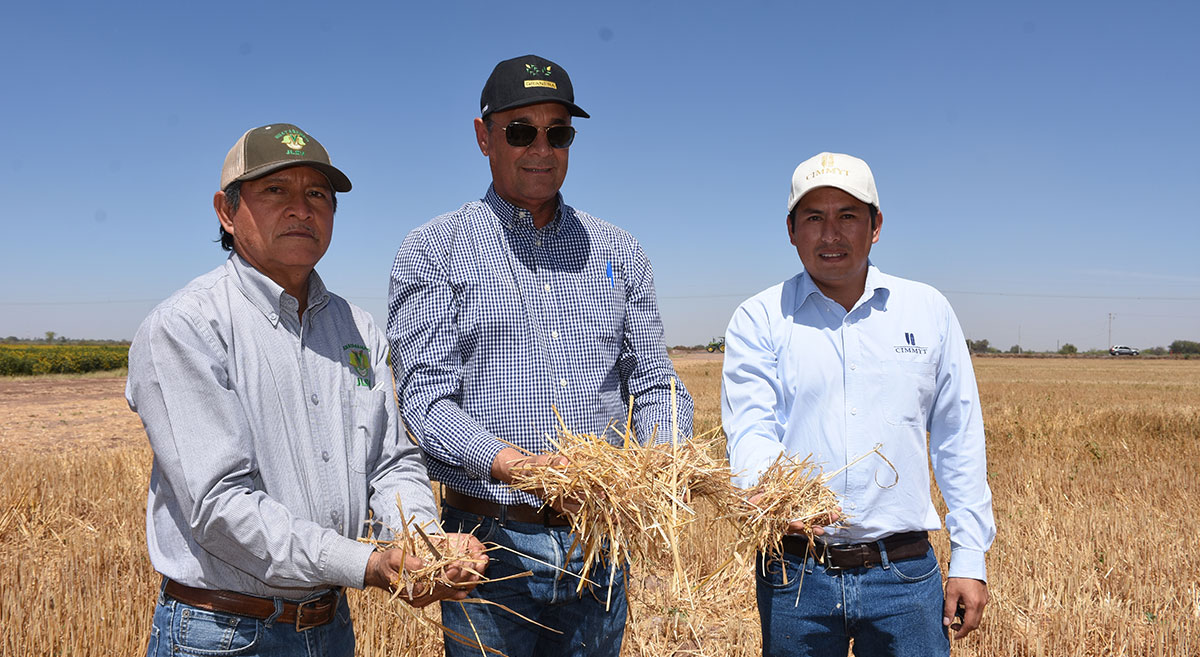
[386,187,692,506]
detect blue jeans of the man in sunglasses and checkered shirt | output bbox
[442,506,629,657]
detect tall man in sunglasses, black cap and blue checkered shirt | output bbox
[388,55,692,657]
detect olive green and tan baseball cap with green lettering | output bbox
[221,123,350,192]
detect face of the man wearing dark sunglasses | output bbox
[475,103,571,211]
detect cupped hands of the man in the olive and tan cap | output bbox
[362,534,487,608]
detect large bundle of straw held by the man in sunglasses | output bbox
[511,411,732,592]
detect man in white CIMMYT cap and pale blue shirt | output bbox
[721,152,996,657]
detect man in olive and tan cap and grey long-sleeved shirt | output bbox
[126,123,486,656]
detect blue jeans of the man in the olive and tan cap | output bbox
[146,580,354,657]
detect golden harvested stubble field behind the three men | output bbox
[0,355,1200,657]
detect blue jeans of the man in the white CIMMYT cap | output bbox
[755,543,950,657]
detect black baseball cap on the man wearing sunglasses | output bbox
[479,55,590,119]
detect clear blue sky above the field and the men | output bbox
[0,1,1200,349]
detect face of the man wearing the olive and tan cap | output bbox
[214,167,334,280]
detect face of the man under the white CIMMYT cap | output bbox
[788,187,883,294]
